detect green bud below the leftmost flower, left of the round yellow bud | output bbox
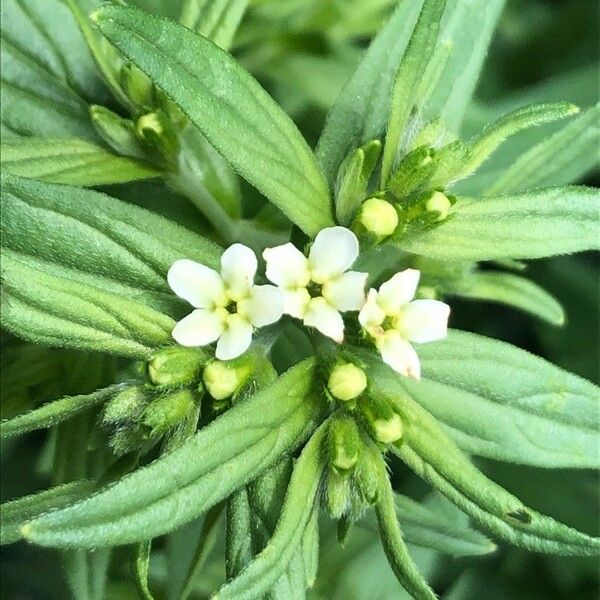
[148,346,206,386]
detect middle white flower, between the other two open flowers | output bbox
[263,227,367,342]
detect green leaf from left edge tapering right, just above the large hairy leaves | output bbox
[0,138,158,186]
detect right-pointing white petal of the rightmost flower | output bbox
[394,299,450,344]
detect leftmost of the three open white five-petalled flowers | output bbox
[167,244,283,360]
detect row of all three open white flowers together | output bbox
[168,227,450,379]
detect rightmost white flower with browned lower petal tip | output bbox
[358,269,450,379]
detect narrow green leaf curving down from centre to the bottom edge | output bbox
[214,424,327,600]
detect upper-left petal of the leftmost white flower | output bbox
[167,258,227,308]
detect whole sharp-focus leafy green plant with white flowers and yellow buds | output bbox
[2,0,600,600]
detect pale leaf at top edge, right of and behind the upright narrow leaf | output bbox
[426,0,505,131]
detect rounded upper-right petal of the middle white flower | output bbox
[308,227,358,283]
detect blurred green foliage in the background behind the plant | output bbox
[0,0,600,600]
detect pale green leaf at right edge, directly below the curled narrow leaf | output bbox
[486,104,600,195]
